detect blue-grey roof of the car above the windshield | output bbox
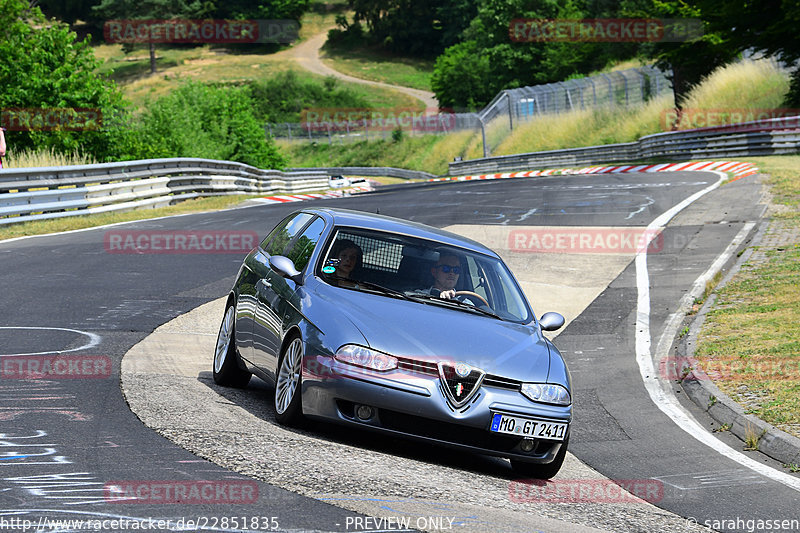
[303,207,500,258]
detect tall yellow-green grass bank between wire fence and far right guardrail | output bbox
[282,57,788,168]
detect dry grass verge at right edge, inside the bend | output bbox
[697,156,800,437]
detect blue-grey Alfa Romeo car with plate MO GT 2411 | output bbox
[213,208,572,478]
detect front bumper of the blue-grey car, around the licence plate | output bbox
[301,356,572,463]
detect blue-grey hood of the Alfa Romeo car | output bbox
[316,289,550,382]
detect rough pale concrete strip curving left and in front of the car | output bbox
[121,299,700,533]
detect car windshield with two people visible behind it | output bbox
[316,228,533,323]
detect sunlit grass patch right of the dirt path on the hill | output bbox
[321,43,433,91]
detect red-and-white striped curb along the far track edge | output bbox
[256,161,758,204]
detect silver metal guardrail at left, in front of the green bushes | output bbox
[0,158,328,225]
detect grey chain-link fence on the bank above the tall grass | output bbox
[264,66,672,151]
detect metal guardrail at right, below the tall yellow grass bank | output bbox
[449,116,800,176]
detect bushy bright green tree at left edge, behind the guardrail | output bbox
[0,0,122,157]
